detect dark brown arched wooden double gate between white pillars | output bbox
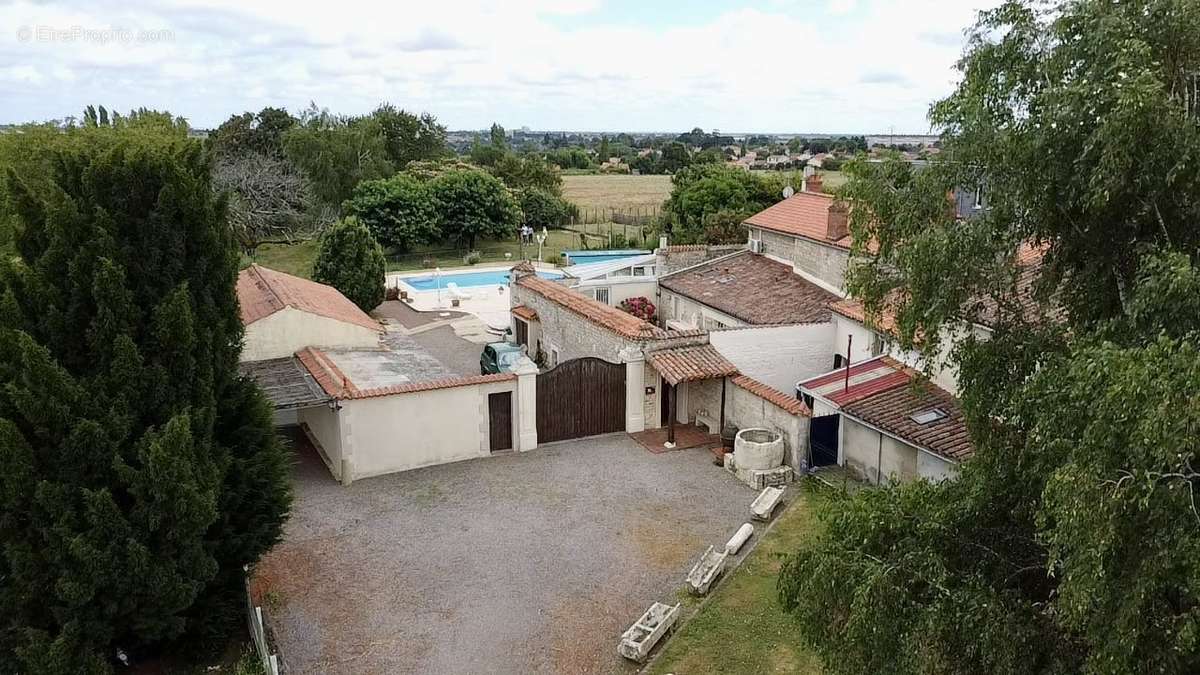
[538,358,625,443]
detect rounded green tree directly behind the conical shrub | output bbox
[346,173,442,252]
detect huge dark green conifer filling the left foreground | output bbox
[0,120,290,673]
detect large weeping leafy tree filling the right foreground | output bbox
[779,0,1200,673]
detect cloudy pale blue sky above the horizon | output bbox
[0,0,995,133]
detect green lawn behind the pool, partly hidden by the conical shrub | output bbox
[241,226,600,279]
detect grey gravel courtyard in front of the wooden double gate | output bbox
[256,434,754,674]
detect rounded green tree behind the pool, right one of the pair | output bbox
[430,169,521,249]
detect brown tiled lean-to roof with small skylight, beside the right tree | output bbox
[842,381,974,460]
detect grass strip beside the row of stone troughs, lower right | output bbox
[649,483,823,675]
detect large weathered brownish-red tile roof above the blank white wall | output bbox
[659,252,838,325]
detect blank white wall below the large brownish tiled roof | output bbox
[708,322,834,395]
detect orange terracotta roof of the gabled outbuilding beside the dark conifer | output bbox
[238,264,382,330]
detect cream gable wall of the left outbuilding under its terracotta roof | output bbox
[240,307,379,362]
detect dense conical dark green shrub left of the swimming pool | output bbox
[312,217,386,311]
